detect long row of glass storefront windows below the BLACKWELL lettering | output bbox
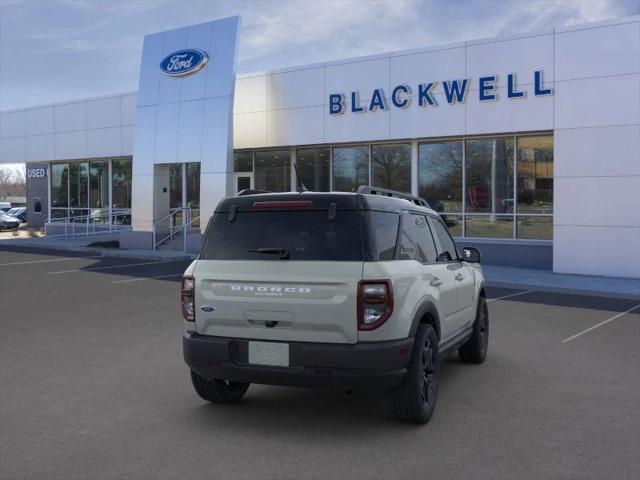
[225,134,553,240]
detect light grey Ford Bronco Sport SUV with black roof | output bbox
[181,187,489,423]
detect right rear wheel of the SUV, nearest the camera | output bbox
[389,324,440,423]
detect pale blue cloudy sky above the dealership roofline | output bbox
[0,0,640,110]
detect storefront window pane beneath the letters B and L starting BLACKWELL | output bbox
[333,145,369,192]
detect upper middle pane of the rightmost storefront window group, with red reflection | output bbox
[466,137,514,213]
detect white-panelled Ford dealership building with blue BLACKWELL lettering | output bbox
[0,16,640,278]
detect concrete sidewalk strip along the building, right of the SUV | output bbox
[482,265,640,302]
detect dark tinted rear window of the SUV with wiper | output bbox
[200,210,364,261]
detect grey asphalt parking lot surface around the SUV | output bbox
[0,249,640,479]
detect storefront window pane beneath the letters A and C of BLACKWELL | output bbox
[371,143,411,193]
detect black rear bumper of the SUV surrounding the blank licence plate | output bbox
[182,333,413,390]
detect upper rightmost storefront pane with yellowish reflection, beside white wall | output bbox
[516,135,553,214]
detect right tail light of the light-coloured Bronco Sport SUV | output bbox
[358,280,393,330]
